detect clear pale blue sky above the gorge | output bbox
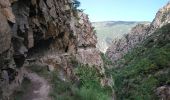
[79,0,169,22]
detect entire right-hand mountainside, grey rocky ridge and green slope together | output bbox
[104,3,170,100]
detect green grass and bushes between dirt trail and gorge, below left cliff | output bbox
[29,62,112,100]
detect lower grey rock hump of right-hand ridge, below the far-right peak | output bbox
[106,24,149,63]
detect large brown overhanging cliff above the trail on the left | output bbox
[0,0,103,99]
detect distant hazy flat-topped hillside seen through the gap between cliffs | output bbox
[92,21,148,52]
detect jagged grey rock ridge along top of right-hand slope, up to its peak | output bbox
[106,3,170,63]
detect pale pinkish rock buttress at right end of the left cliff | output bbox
[76,12,103,67]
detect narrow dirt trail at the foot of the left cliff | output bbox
[22,72,51,100]
